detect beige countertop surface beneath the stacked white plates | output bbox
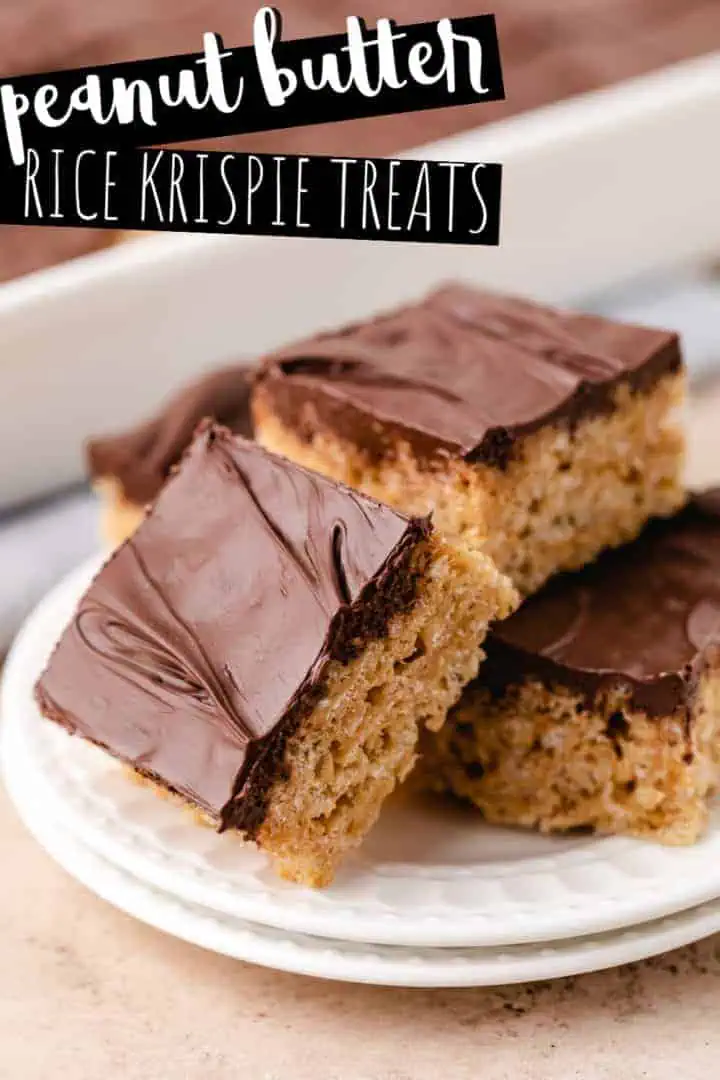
[0,397,720,1080]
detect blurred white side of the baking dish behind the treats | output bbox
[0,48,720,507]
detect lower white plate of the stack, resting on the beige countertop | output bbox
[2,725,720,987]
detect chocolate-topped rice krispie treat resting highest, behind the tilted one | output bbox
[253,285,683,594]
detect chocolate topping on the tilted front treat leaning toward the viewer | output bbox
[37,427,430,833]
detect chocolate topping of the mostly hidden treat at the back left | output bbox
[86,366,253,504]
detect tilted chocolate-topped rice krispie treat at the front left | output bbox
[37,428,515,886]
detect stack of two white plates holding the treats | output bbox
[2,564,720,986]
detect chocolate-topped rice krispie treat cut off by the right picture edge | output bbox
[422,489,720,843]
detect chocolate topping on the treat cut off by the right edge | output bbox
[480,488,720,715]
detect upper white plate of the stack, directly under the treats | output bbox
[2,563,720,946]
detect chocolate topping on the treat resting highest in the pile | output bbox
[258,285,681,468]
